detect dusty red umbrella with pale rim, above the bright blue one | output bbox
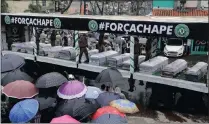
[3,80,38,99]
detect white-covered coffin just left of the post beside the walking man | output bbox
[58,47,76,60]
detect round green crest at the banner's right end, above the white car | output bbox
[174,24,190,37]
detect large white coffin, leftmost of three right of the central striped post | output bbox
[139,56,168,74]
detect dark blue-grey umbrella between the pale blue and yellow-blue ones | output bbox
[96,92,120,107]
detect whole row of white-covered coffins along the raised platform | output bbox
[12,42,208,82]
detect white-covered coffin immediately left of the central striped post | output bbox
[107,53,130,67]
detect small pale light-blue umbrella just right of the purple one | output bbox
[85,86,102,99]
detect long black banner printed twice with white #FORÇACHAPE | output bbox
[1,14,209,40]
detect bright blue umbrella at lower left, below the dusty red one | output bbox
[9,99,39,123]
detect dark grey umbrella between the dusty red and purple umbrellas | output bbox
[36,72,68,88]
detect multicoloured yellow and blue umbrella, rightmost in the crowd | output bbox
[110,99,139,114]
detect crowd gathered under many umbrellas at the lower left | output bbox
[1,54,139,123]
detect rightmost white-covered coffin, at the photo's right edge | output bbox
[185,62,208,82]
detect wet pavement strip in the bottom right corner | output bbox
[128,110,209,124]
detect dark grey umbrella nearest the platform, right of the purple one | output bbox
[95,68,129,89]
